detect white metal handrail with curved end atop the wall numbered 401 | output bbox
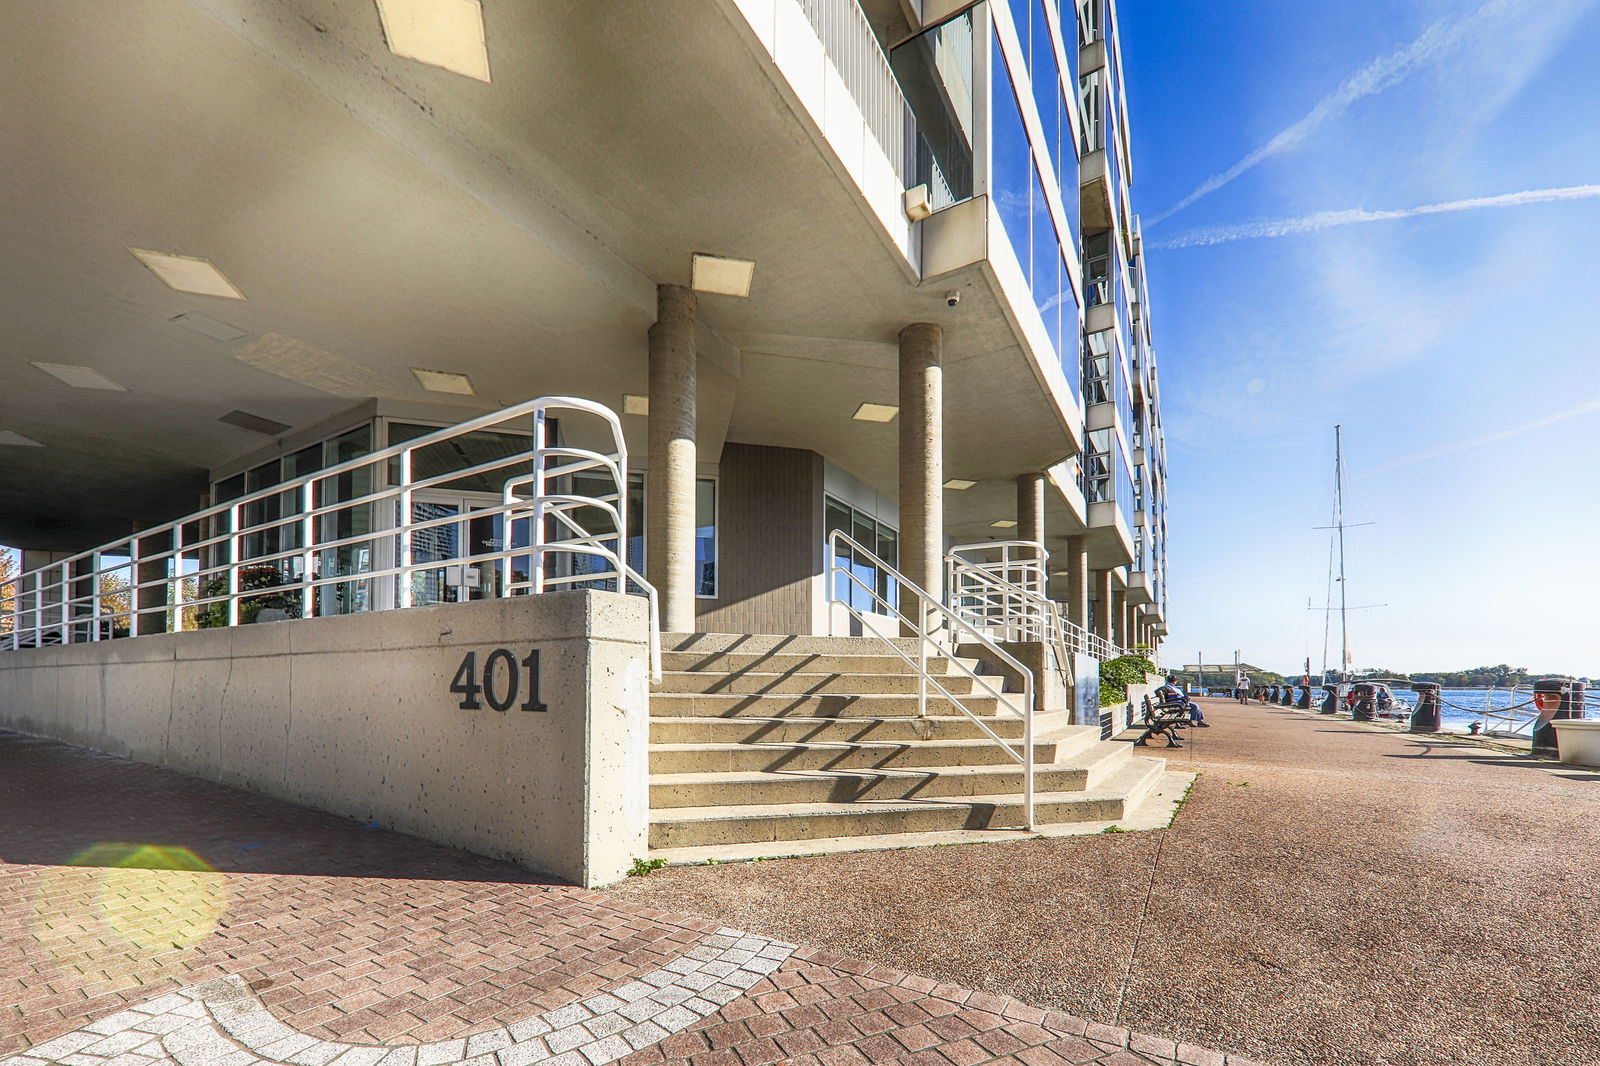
[0,395,661,680]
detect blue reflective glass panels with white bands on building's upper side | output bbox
[987,0,1082,399]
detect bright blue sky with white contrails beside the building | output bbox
[1120,0,1600,675]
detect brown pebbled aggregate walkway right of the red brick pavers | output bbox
[616,699,1600,1066]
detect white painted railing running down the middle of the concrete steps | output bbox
[826,530,1035,829]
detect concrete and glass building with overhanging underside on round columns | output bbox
[0,0,1168,879]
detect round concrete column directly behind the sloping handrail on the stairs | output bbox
[899,322,944,627]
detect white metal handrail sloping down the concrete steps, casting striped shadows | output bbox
[826,530,1035,831]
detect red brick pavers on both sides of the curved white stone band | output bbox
[0,733,1246,1066]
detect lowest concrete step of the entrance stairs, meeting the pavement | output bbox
[650,757,1166,861]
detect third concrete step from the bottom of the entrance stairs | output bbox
[650,736,1058,775]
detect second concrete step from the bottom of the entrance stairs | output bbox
[650,741,1133,812]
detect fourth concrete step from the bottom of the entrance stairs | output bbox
[650,712,1099,742]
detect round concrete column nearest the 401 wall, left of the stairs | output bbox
[645,285,694,632]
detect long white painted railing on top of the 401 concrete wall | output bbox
[0,397,661,679]
